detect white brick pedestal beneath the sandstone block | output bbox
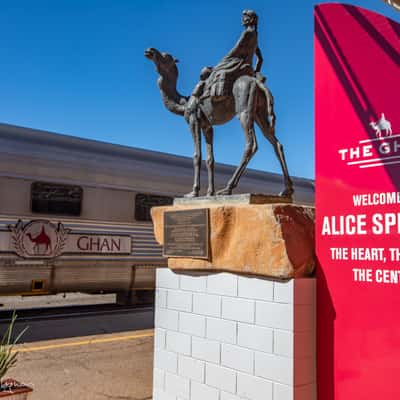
[153,268,316,400]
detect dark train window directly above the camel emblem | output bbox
[31,182,83,216]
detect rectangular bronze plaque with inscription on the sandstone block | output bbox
[164,208,209,259]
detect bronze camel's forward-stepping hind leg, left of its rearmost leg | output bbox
[217,111,257,195]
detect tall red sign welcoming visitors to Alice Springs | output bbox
[315,4,400,400]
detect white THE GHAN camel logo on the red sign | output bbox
[338,113,400,168]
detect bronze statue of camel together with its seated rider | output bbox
[145,10,293,197]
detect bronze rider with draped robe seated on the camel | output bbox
[202,10,265,98]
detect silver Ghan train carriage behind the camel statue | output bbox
[0,124,314,301]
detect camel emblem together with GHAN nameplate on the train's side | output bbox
[6,220,132,259]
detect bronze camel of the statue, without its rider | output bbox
[145,48,294,197]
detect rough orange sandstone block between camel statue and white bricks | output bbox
[151,203,315,279]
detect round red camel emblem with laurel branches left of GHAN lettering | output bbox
[9,220,70,258]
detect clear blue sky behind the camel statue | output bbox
[0,0,399,178]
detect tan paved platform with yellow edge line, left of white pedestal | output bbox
[9,330,153,400]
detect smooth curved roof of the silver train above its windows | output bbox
[0,123,314,203]
